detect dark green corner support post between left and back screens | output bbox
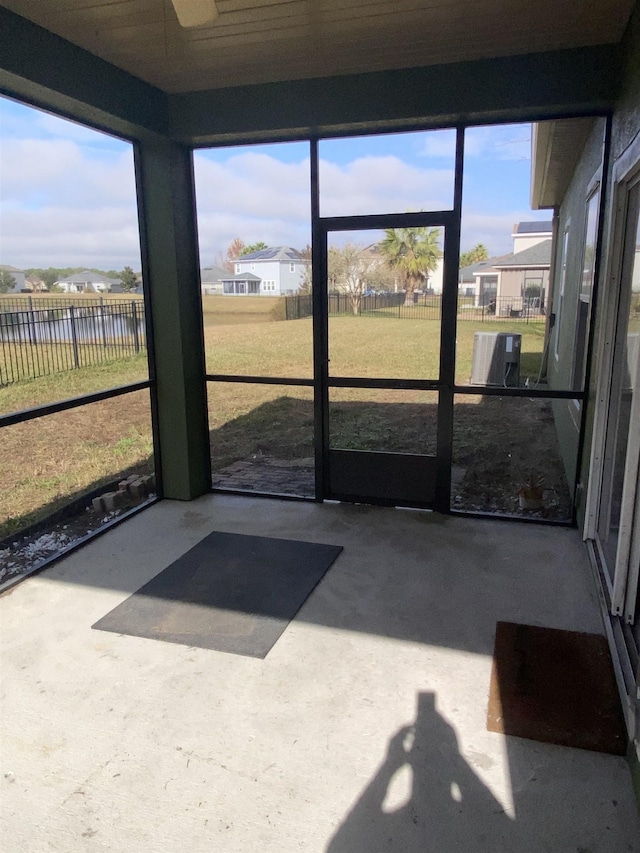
[135,138,211,500]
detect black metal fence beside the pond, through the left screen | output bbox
[0,300,146,386]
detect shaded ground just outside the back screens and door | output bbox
[211,389,572,520]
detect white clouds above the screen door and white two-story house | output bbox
[195,151,453,263]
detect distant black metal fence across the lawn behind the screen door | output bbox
[285,293,545,323]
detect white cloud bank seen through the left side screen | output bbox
[0,126,140,269]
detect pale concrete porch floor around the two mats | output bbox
[0,495,640,853]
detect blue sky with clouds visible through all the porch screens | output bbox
[0,98,550,271]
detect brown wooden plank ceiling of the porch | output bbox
[3,0,634,93]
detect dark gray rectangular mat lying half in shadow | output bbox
[93,533,342,658]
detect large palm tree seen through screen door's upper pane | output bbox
[380,227,442,302]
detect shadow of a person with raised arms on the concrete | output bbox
[326,692,517,853]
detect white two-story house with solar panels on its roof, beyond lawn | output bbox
[232,246,309,296]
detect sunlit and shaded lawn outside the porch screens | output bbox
[0,312,548,539]
